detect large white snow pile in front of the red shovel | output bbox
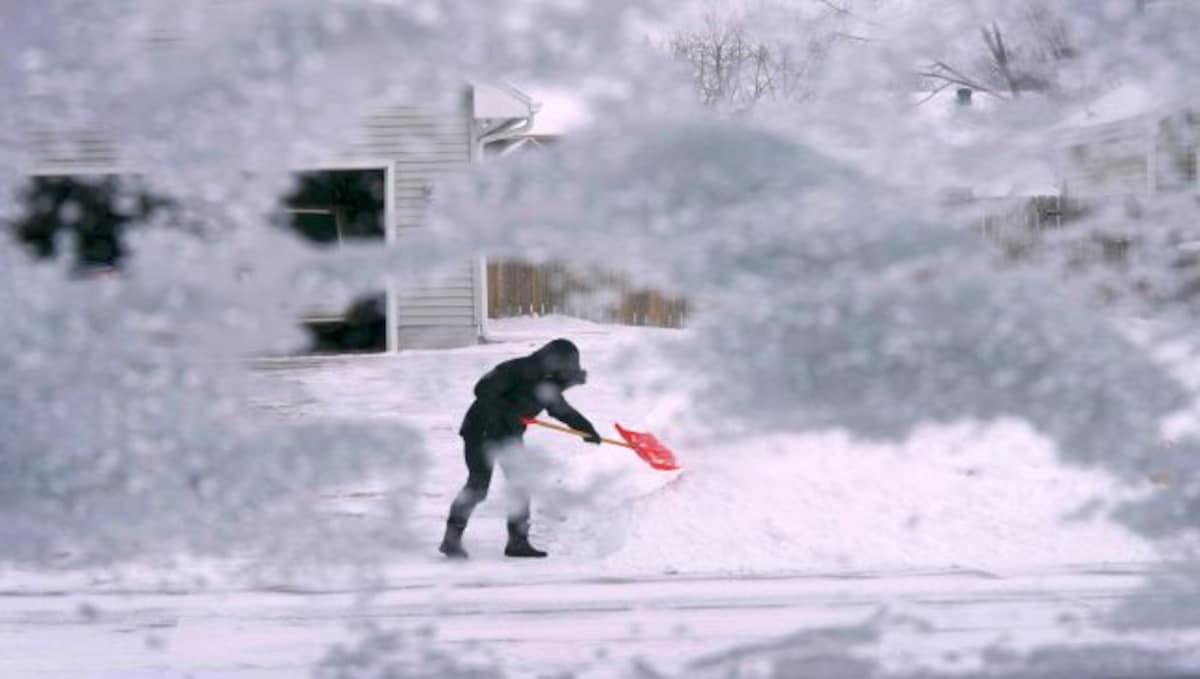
[592,421,1154,572]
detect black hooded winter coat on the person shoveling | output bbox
[458,340,599,440]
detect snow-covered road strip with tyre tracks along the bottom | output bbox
[7,564,1200,679]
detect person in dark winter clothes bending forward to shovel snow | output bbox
[438,340,602,559]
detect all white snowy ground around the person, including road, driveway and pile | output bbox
[0,318,1198,678]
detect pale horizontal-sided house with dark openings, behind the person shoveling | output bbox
[16,85,545,350]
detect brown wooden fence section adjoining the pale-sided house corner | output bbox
[487,262,689,328]
